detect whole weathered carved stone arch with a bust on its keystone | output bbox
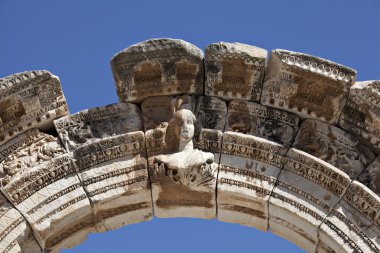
[0,39,380,253]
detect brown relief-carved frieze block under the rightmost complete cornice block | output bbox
[293,119,375,179]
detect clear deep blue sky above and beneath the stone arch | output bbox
[0,0,380,253]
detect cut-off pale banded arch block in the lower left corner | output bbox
[0,193,41,253]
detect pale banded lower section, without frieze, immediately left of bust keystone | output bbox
[73,132,153,232]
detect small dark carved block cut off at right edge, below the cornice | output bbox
[358,156,380,196]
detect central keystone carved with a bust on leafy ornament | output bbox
[141,96,221,219]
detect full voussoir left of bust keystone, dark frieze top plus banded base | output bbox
[54,103,153,232]
